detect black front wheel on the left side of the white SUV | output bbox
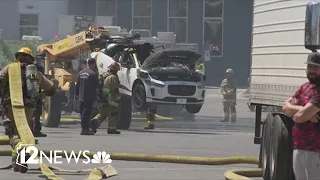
[132,83,148,111]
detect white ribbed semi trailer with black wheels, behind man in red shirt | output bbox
[249,0,320,180]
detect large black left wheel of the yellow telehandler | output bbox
[42,84,64,127]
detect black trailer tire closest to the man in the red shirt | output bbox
[270,115,294,180]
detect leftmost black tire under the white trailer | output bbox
[260,113,274,180]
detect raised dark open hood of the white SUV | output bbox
[141,49,201,70]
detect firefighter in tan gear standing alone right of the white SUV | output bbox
[221,69,237,122]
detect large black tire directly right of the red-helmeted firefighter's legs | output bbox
[117,96,132,130]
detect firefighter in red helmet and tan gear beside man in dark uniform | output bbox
[90,62,121,134]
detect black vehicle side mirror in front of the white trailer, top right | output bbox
[304,2,320,52]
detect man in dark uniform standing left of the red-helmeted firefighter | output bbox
[75,58,99,135]
